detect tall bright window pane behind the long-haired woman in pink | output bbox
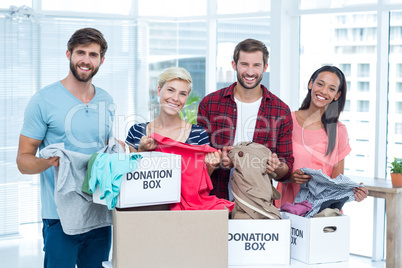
[299,12,377,256]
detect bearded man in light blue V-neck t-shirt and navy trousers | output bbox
[17,28,114,268]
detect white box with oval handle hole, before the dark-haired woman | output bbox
[284,213,350,264]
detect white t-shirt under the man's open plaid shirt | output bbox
[228,97,262,201]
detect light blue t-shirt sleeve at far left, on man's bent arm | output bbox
[21,93,48,140]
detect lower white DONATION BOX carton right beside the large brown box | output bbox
[228,219,291,266]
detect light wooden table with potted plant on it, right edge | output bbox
[356,178,402,268]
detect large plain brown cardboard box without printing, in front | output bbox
[112,210,228,268]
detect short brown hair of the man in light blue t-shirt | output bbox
[67,28,107,58]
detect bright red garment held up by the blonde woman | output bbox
[151,133,234,211]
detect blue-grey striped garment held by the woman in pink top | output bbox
[294,168,363,218]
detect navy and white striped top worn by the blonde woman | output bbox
[126,122,209,151]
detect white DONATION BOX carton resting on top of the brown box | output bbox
[92,152,181,208]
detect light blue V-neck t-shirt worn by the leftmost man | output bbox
[21,81,115,219]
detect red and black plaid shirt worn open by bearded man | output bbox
[197,83,294,199]
